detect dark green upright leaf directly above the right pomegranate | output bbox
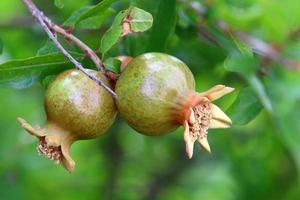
[147,0,176,52]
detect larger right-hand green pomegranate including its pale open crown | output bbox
[115,53,233,158]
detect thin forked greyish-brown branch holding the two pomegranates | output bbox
[22,0,117,99]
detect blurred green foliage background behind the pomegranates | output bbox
[0,0,300,200]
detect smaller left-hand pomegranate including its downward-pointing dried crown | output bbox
[18,69,116,172]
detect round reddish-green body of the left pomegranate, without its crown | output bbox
[45,69,116,139]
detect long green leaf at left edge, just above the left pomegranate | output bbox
[0,53,83,89]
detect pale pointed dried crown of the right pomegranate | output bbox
[181,85,234,158]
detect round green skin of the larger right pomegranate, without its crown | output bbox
[115,53,195,136]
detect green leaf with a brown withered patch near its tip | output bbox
[100,7,152,55]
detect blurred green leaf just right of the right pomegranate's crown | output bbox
[228,87,263,125]
